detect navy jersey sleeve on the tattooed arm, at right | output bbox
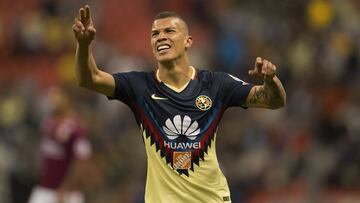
[216,72,254,108]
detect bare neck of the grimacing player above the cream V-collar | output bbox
[157,55,194,88]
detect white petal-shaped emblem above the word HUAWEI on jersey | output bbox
[163,115,200,140]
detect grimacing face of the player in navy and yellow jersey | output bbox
[151,17,192,62]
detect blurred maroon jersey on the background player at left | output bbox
[40,117,91,189]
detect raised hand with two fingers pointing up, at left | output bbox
[72,5,96,45]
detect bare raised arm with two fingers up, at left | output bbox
[72,6,115,97]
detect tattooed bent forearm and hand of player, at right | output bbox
[246,57,286,109]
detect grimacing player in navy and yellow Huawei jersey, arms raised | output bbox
[73,6,286,203]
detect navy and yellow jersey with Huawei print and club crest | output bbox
[109,69,252,203]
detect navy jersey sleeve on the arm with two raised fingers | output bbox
[108,71,144,105]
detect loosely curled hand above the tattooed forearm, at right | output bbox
[249,57,276,82]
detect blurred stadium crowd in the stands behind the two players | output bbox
[0,0,360,203]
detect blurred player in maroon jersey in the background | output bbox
[29,87,91,203]
